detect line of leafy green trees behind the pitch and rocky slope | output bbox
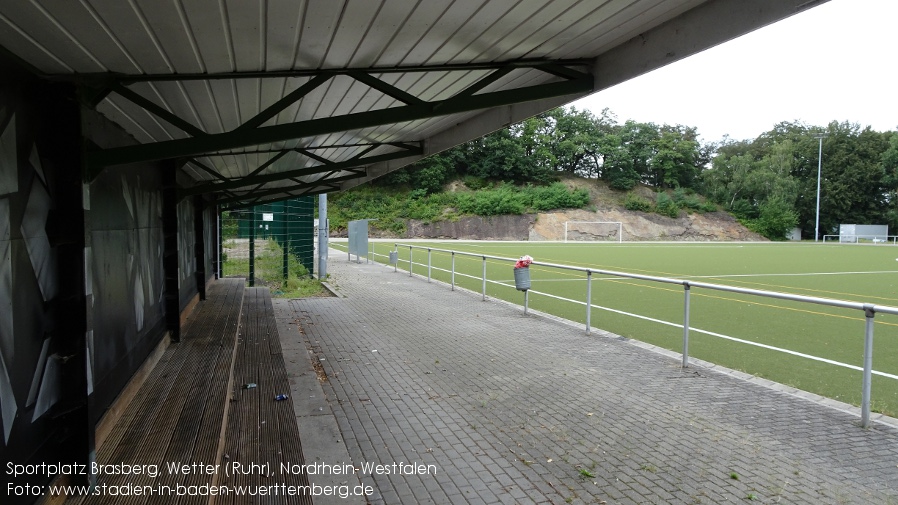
[383,108,898,238]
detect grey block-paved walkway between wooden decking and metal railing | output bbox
[276,253,898,504]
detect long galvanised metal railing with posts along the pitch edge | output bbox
[394,243,898,428]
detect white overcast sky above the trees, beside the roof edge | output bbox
[572,0,898,141]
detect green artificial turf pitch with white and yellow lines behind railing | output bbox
[332,241,898,416]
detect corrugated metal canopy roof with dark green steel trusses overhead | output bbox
[0,0,825,206]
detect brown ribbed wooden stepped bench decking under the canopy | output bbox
[67,279,312,505]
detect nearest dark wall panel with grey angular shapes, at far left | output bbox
[0,53,92,503]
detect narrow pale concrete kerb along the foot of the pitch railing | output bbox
[373,250,898,428]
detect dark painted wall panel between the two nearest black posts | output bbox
[89,161,165,421]
